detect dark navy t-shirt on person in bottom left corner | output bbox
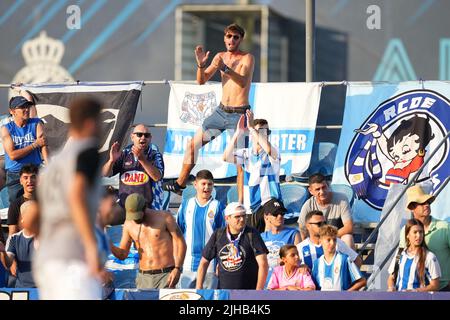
[6,230,36,288]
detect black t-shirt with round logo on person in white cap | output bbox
[202,226,269,290]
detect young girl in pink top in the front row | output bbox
[268,244,316,291]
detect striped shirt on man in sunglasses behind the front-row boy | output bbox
[297,238,358,270]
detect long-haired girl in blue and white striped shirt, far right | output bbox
[388,219,441,292]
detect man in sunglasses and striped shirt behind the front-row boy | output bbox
[297,210,362,270]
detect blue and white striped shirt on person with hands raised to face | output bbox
[234,146,281,214]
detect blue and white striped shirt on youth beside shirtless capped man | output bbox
[177,197,225,272]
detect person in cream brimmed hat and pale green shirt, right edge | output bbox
[400,185,450,291]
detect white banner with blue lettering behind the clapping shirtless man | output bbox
[164,82,321,179]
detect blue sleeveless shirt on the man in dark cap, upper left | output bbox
[5,118,42,172]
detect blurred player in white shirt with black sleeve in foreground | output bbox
[33,96,103,300]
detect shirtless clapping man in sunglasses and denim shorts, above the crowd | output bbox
[163,23,255,201]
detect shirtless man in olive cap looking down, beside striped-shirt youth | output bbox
[111,193,186,289]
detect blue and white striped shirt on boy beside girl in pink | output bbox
[312,251,362,291]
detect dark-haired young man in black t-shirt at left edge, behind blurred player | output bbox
[6,164,39,236]
